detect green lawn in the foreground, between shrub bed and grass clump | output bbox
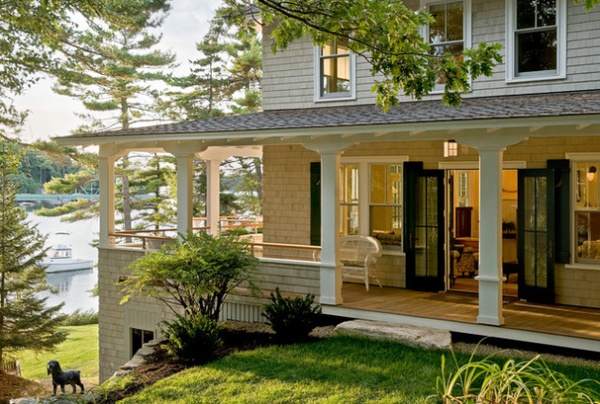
[121,337,600,404]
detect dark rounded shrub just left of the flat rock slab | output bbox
[262,288,321,342]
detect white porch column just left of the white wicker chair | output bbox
[320,151,343,304]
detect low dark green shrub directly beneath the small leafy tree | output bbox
[163,313,223,363]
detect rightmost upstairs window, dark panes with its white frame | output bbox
[506,0,566,80]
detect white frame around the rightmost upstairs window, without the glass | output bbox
[505,0,567,83]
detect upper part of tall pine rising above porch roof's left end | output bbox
[51,0,175,132]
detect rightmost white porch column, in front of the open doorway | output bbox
[475,146,504,325]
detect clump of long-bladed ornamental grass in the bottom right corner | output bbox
[430,344,600,404]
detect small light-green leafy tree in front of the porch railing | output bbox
[122,231,258,321]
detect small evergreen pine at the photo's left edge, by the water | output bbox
[0,140,66,362]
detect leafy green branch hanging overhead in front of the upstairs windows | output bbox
[226,0,600,110]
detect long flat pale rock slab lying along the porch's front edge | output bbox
[335,320,452,349]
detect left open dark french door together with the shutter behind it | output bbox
[403,162,445,291]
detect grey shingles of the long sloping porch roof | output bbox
[62,90,600,138]
